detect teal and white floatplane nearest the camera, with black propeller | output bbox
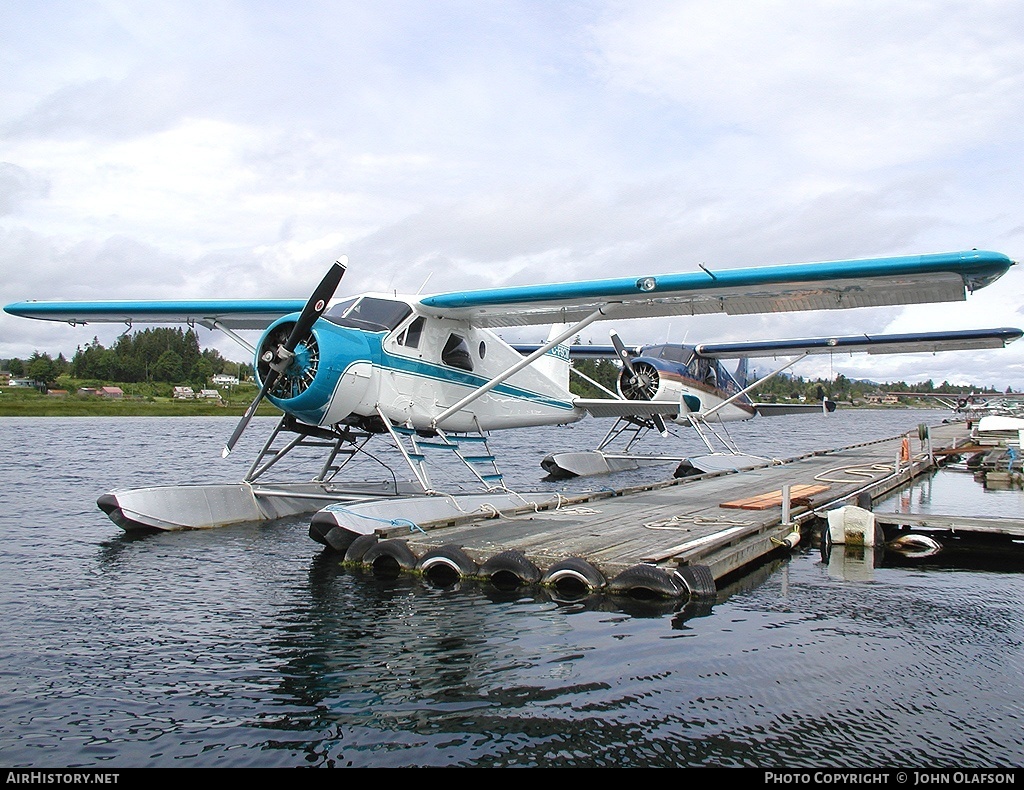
[4,250,1014,548]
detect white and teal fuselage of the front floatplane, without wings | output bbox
[257,294,585,431]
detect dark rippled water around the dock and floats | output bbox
[0,411,1024,770]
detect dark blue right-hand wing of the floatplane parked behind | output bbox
[694,327,1024,360]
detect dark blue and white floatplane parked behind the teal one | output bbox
[532,328,1024,480]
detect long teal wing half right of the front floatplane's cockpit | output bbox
[419,250,1014,327]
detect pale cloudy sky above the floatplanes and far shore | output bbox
[0,0,1024,391]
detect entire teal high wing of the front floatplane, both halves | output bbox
[4,250,1014,329]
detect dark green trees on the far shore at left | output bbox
[7,327,252,387]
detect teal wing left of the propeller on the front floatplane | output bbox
[4,299,305,329]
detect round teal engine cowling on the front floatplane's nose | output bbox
[256,316,374,425]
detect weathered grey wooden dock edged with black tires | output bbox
[348,423,1024,597]
